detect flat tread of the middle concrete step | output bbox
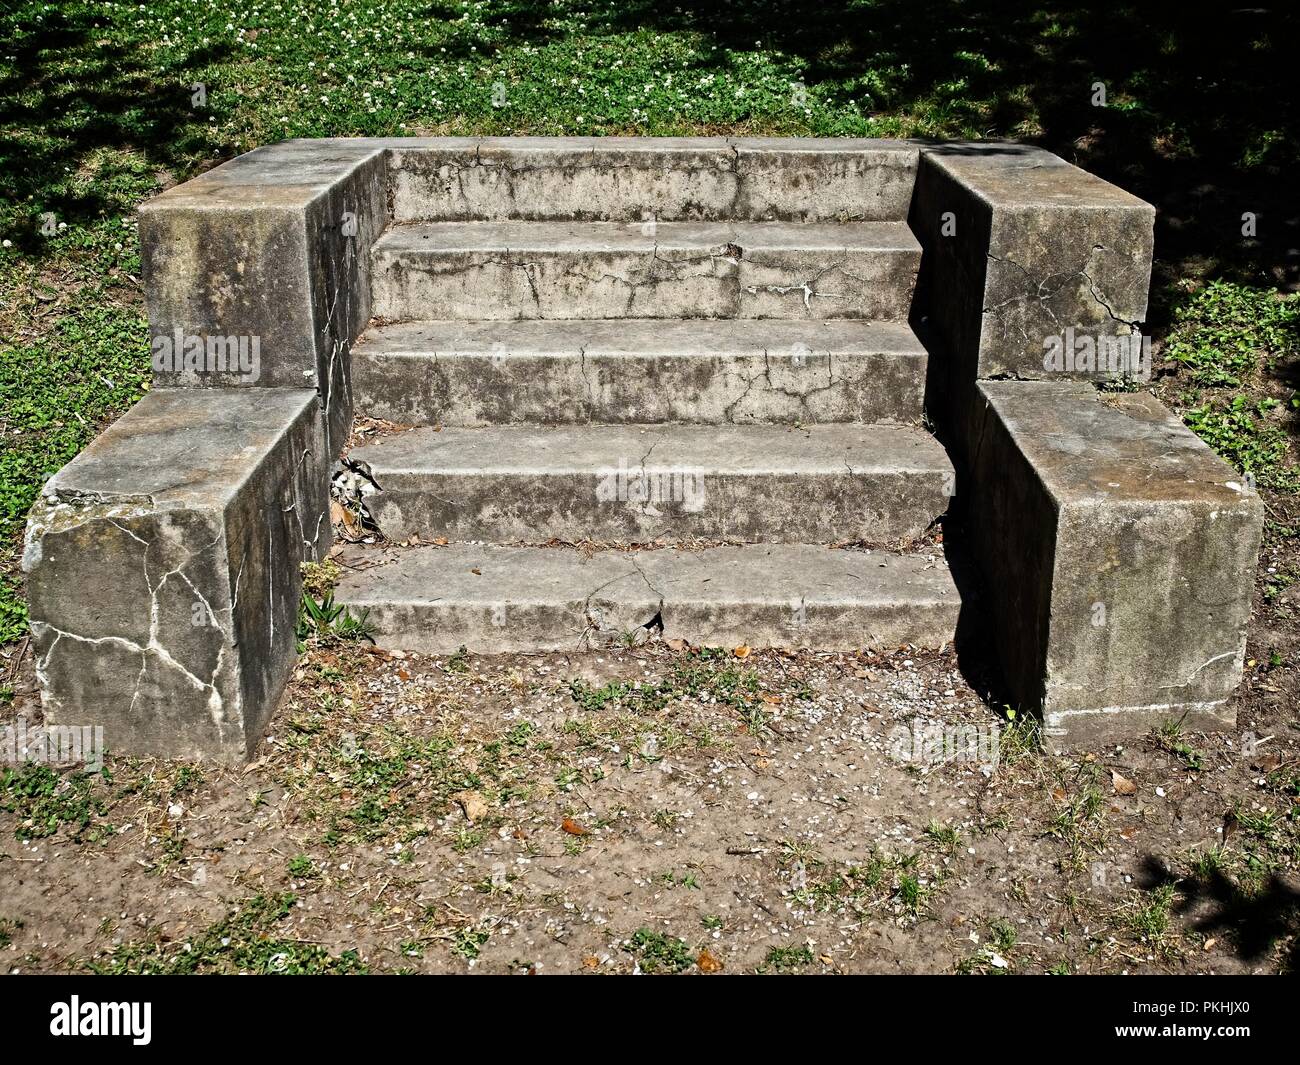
[355,319,926,356]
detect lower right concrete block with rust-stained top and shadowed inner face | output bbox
[959,381,1264,748]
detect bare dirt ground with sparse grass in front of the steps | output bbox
[0,557,1300,973]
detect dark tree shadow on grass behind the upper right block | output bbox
[587,0,1300,286]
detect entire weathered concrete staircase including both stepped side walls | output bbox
[23,138,1264,762]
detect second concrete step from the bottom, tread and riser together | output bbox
[351,425,953,544]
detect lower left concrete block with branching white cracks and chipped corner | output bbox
[23,389,330,762]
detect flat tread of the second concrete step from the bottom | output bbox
[351,424,952,475]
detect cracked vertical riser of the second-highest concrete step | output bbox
[372,246,920,321]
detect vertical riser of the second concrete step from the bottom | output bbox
[368,473,952,544]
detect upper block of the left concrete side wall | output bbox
[140,139,387,451]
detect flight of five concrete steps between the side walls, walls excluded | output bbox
[338,140,959,650]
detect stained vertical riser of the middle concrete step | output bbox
[352,345,926,425]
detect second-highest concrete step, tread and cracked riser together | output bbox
[371,222,920,321]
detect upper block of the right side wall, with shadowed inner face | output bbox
[909,143,1156,392]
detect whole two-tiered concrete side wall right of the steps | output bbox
[910,144,1262,746]
